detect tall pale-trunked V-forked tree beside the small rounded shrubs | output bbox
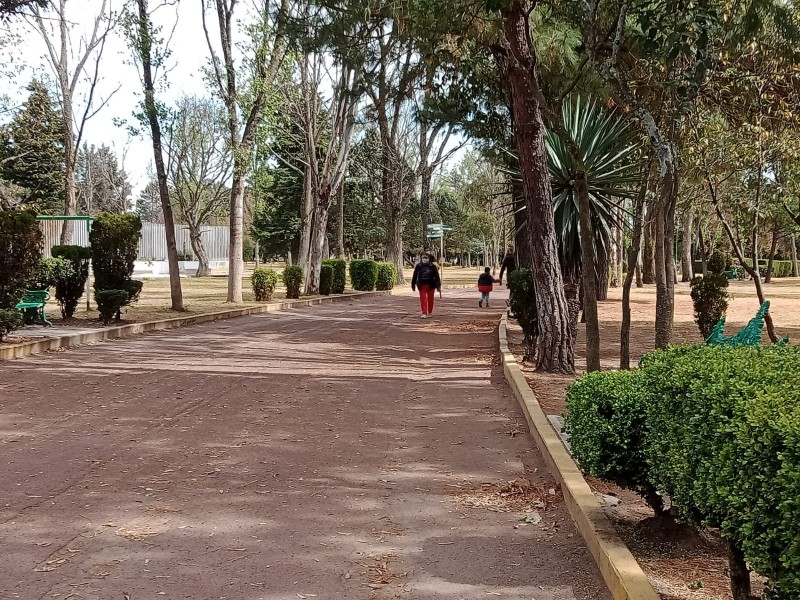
[203,0,289,302]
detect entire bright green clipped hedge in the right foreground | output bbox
[566,346,800,599]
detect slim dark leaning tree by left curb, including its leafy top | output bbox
[126,0,183,311]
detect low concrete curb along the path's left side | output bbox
[0,290,392,361]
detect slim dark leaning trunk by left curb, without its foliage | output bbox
[137,0,184,311]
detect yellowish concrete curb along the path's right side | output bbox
[499,313,661,600]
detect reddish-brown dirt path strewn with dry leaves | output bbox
[0,291,610,600]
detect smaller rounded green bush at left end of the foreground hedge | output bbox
[565,370,664,514]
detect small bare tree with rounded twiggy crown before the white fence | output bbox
[167,97,233,277]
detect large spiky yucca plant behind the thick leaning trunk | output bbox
[545,96,639,292]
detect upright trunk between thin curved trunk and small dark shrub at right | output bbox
[655,161,677,350]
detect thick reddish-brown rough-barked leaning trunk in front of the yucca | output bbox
[501,1,575,373]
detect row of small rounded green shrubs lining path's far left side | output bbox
[251,259,397,302]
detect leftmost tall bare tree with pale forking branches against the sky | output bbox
[32,0,119,244]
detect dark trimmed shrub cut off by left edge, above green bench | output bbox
[0,210,42,309]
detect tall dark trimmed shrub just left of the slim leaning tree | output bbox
[89,213,142,322]
